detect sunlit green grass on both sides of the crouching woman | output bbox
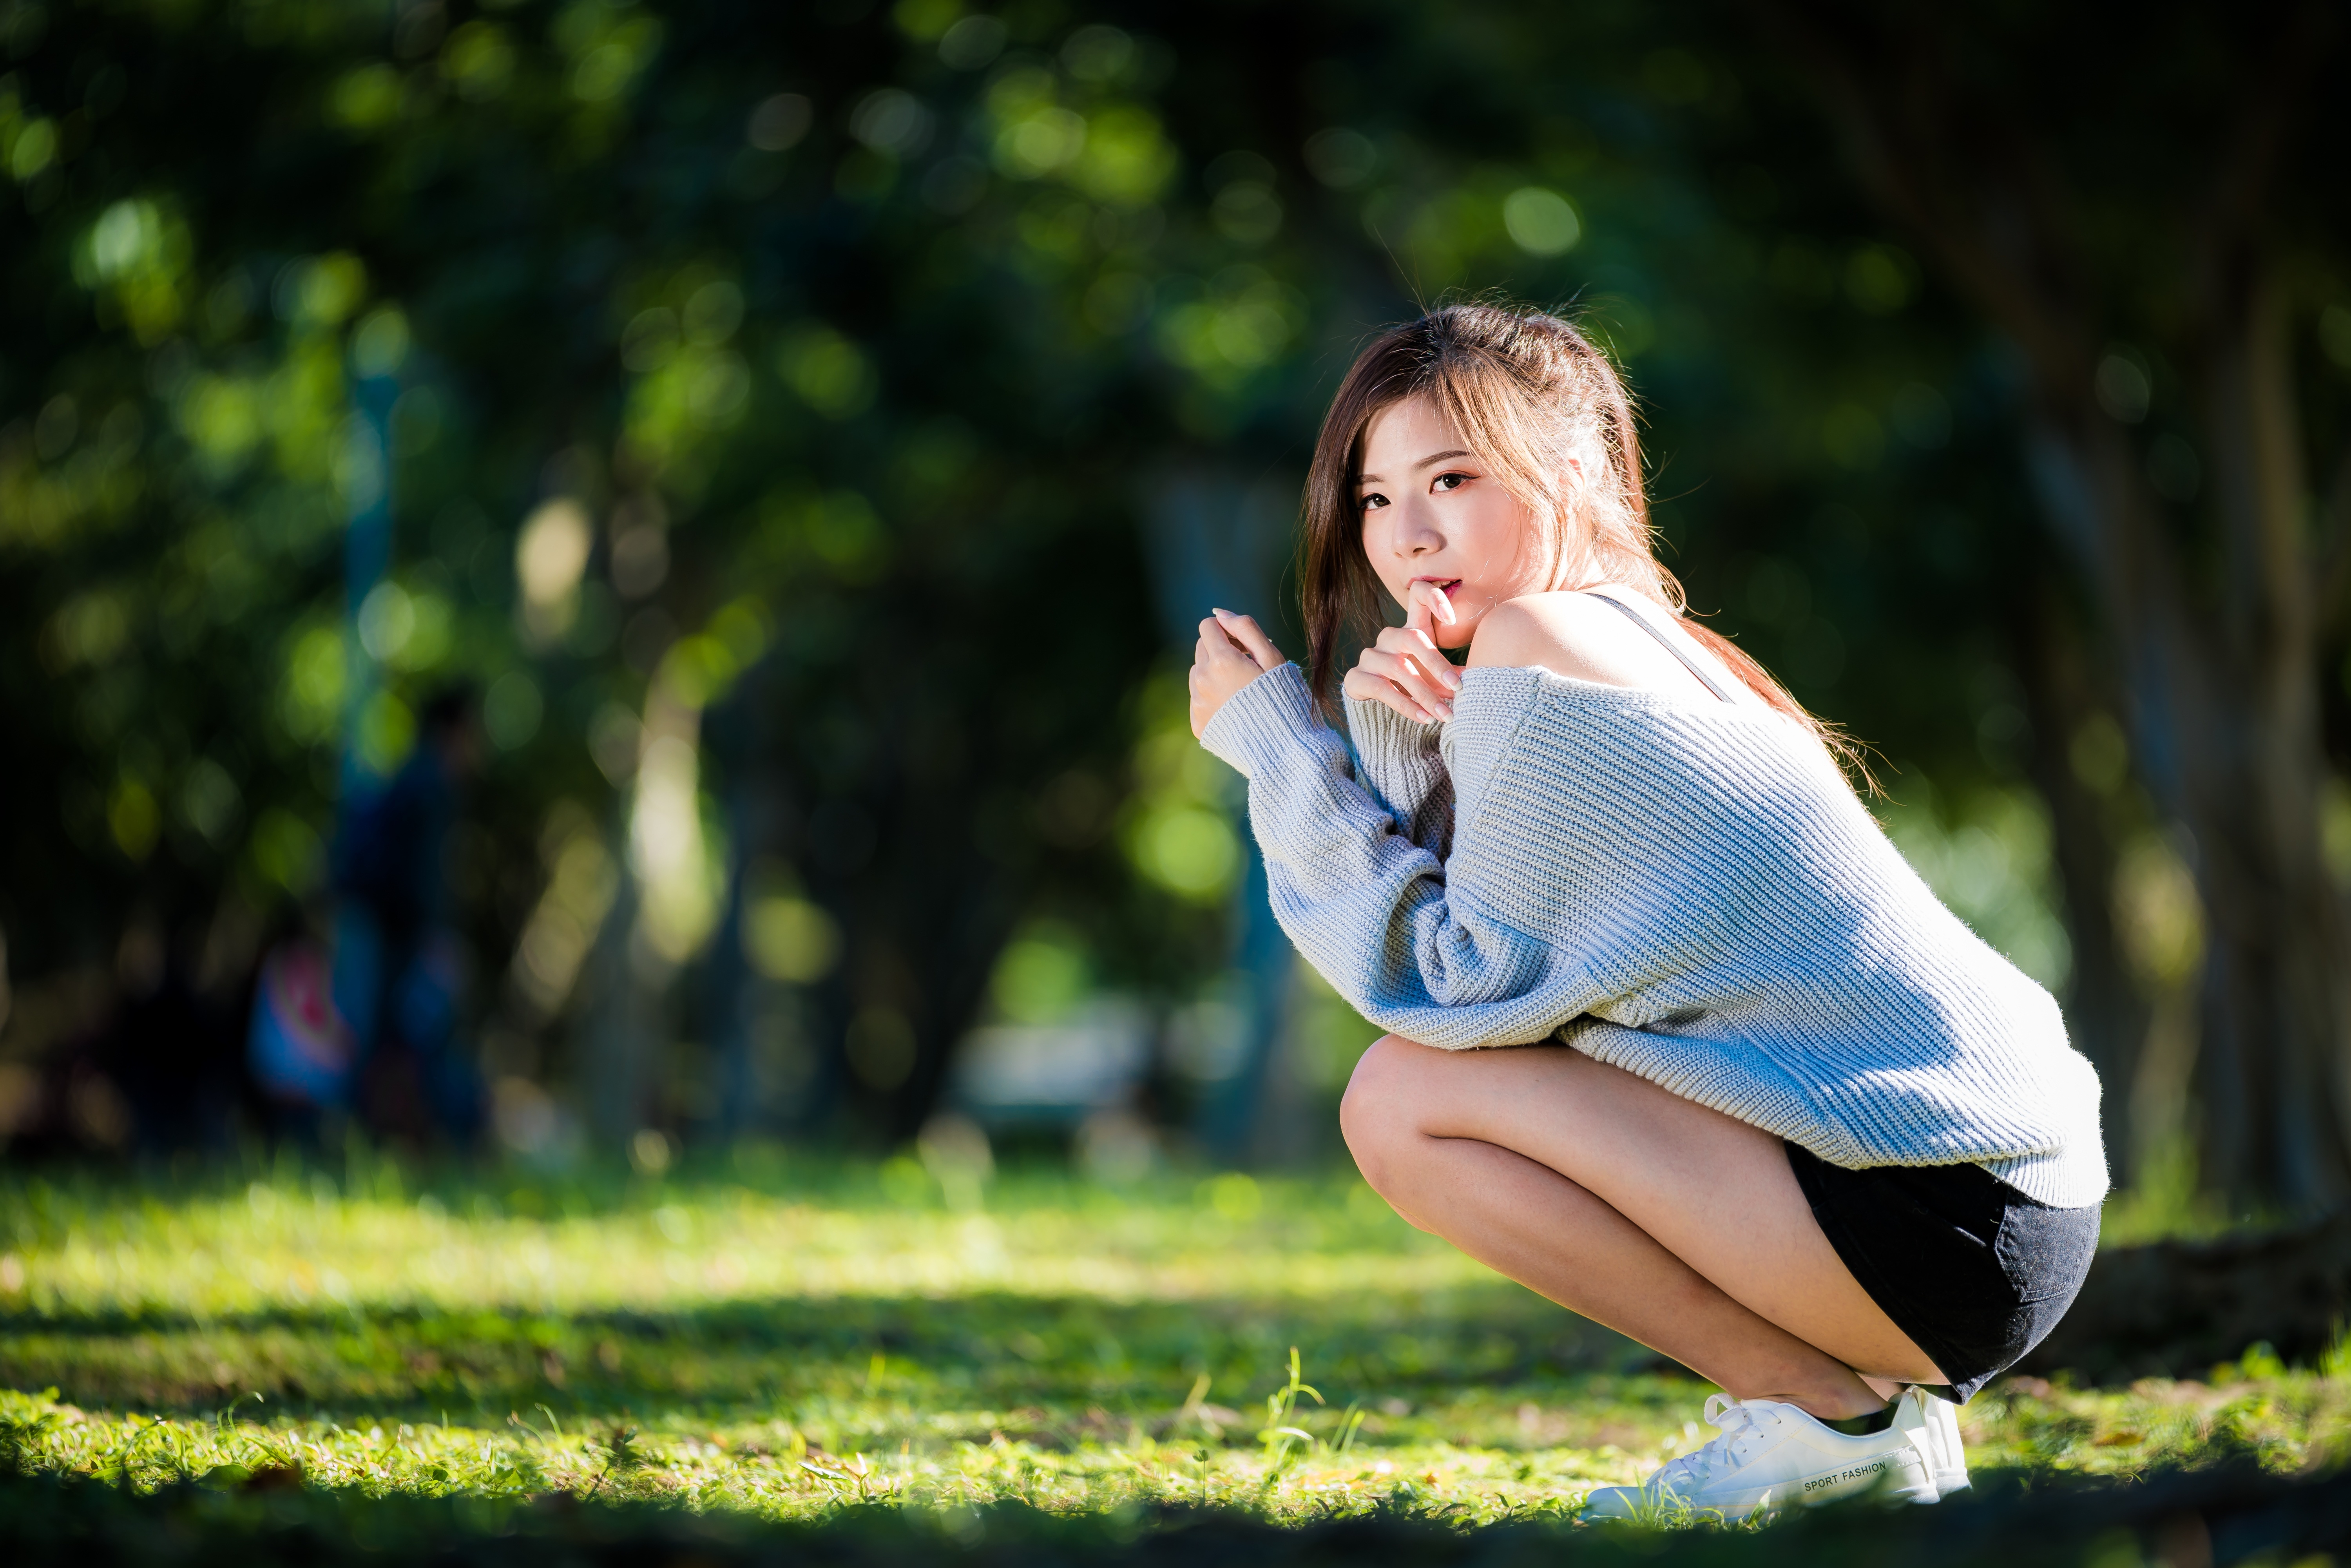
[0,1147,2351,1523]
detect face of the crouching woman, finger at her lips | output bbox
[1357,397,1552,649]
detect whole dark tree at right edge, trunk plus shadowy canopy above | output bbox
[1763,5,2351,1208]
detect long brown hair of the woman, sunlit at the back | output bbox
[1300,306,1860,766]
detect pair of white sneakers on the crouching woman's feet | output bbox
[1585,1394,1942,1523]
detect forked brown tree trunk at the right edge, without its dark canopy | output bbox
[2036,371,2351,1211]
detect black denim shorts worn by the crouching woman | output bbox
[1787,1143,2099,1401]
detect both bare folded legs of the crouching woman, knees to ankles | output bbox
[1340,1034,1944,1420]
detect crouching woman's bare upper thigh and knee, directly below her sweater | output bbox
[1345,1034,1940,1382]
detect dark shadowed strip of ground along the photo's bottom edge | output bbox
[0,1469,2351,1568]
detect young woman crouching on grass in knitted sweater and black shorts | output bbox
[1192,306,2106,1516]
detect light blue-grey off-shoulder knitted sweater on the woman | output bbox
[1204,665,2106,1208]
